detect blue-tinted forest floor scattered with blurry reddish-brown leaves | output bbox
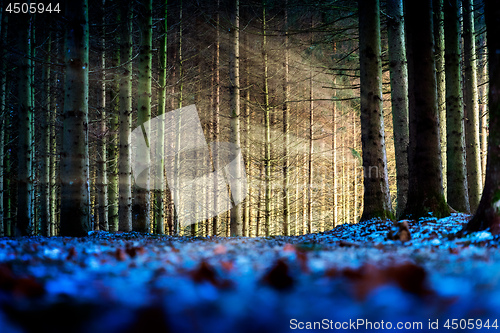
[0,214,500,333]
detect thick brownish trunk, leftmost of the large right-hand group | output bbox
[358,0,393,221]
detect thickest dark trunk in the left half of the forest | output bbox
[61,0,92,236]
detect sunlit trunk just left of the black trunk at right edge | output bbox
[462,0,482,211]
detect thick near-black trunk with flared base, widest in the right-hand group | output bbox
[403,0,450,219]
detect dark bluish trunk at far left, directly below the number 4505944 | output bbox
[16,15,34,236]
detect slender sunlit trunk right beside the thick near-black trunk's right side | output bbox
[432,0,448,198]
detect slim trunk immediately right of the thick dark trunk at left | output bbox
[96,0,109,231]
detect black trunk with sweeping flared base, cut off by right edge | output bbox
[464,0,500,234]
